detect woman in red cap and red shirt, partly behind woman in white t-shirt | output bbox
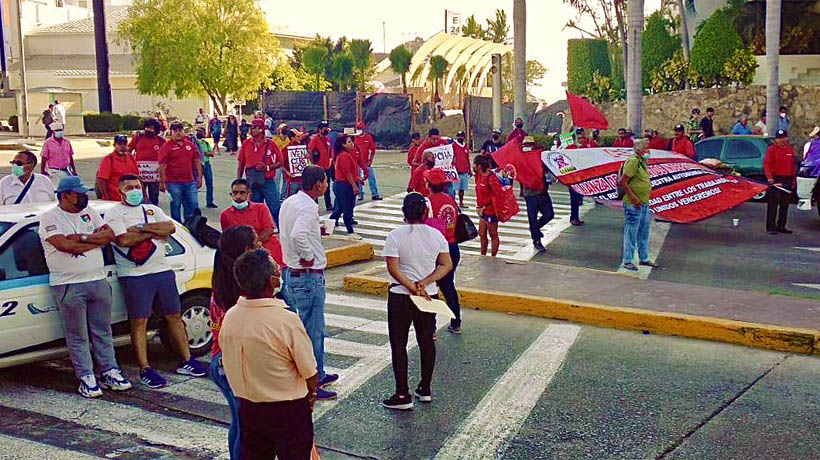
[424,169,461,334]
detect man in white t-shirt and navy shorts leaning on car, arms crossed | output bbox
[105,174,207,388]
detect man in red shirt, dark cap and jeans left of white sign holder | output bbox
[236,118,282,226]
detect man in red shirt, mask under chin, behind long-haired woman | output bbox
[219,179,284,267]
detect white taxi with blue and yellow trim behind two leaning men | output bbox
[0,201,214,368]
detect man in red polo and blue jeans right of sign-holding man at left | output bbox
[157,121,202,222]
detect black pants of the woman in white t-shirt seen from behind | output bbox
[387,292,437,395]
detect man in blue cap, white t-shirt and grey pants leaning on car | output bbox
[39,176,131,398]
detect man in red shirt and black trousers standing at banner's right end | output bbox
[763,130,797,235]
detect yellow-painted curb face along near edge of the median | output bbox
[344,269,820,354]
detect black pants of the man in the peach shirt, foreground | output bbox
[237,397,313,460]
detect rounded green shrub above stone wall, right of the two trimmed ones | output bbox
[691,9,743,86]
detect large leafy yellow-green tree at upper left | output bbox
[118,0,279,114]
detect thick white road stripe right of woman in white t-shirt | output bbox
[435,324,581,460]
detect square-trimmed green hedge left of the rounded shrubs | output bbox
[567,38,612,94]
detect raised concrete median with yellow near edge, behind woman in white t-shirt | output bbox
[344,256,820,354]
